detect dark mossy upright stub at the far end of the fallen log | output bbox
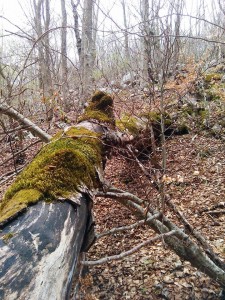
[78,91,115,126]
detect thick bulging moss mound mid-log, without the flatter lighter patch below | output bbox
[5,128,101,199]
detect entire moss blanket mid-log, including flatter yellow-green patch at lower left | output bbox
[0,127,102,221]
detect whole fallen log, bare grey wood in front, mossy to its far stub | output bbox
[0,92,114,300]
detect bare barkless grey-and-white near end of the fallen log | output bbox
[0,196,88,300]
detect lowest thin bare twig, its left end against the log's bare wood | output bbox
[82,230,177,266]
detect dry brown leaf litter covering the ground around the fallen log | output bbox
[0,68,225,300]
